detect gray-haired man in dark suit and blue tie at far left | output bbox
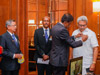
[1,20,22,75]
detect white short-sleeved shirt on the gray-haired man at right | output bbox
[72,28,99,68]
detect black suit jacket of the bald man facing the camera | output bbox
[34,28,51,60]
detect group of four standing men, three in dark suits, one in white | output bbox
[0,13,99,75]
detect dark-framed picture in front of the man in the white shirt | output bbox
[69,57,83,75]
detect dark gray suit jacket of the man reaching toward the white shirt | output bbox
[50,23,82,67]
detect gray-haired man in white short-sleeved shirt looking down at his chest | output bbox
[72,16,98,75]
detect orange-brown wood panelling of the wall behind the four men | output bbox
[0,0,100,75]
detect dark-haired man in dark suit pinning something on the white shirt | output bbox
[50,14,87,75]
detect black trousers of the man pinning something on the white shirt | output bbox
[52,66,67,75]
